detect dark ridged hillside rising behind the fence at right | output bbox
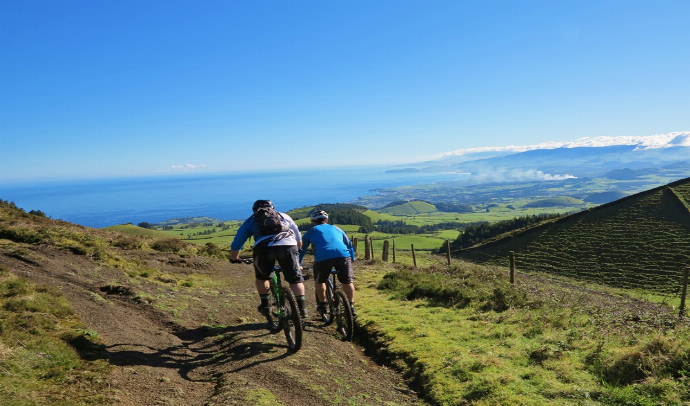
[455,178,690,293]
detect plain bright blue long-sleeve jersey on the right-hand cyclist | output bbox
[299,223,355,263]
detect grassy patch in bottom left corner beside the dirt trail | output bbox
[0,268,108,405]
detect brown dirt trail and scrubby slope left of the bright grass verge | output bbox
[0,201,419,406]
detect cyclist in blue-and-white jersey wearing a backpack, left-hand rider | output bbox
[230,200,307,318]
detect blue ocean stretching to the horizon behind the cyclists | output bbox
[0,167,464,228]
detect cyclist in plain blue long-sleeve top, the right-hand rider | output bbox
[299,210,355,314]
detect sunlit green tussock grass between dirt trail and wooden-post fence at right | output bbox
[357,256,690,405]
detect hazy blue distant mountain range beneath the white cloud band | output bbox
[387,145,690,181]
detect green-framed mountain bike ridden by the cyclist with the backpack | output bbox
[266,266,302,351]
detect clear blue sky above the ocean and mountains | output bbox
[0,0,690,183]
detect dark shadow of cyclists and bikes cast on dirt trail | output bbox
[70,323,292,382]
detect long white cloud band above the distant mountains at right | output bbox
[434,131,690,158]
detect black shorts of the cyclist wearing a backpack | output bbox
[249,245,304,283]
